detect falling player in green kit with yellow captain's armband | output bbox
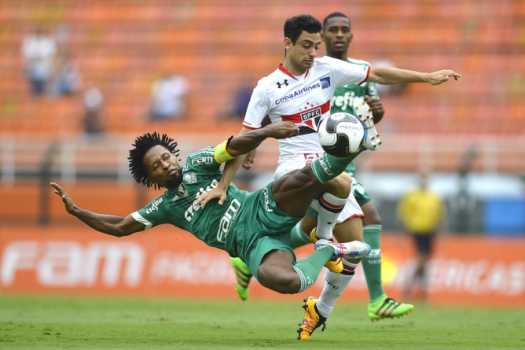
[51,122,370,302]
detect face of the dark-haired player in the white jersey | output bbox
[285,30,321,75]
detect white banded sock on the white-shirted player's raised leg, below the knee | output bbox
[315,192,346,239]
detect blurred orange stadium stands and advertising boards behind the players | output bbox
[0,0,525,306]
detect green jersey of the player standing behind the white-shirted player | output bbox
[330,58,379,173]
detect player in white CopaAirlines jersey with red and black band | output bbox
[198,15,460,339]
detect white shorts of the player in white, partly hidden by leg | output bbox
[274,154,365,223]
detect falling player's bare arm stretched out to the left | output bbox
[51,182,144,237]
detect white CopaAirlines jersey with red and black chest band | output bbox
[243,56,370,164]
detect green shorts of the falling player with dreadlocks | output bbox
[228,183,301,280]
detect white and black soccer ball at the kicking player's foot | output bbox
[318,112,365,158]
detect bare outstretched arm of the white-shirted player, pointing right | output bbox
[367,67,461,85]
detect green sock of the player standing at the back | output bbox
[361,225,384,300]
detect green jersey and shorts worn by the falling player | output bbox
[131,147,300,271]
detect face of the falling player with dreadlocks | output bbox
[144,145,182,190]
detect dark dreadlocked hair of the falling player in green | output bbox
[128,131,179,189]
